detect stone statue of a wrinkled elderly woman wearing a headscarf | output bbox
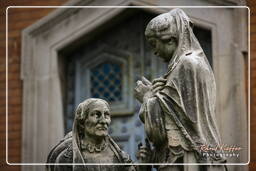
[47,98,135,171]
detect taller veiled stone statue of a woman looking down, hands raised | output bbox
[134,9,226,171]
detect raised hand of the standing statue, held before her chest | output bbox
[134,80,153,103]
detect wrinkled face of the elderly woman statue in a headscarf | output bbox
[84,101,111,137]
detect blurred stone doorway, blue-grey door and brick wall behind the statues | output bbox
[0,0,252,171]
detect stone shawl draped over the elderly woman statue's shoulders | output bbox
[47,132,136,171]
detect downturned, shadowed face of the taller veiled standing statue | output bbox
[148,37,177,62]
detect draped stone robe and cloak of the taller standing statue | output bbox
[140,51,225,171]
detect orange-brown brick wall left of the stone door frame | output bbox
[0,0,66,171]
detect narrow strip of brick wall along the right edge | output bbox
[247,0,256,171]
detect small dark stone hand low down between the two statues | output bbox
[136,139,153,163]
